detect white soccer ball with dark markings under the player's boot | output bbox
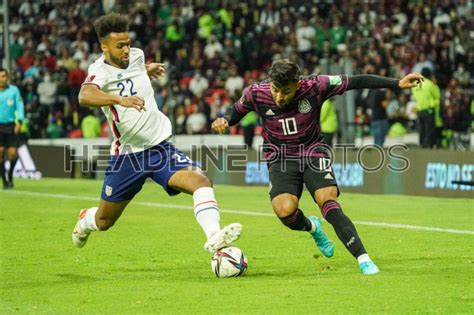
[211,246,248,278]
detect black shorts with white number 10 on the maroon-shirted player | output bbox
[269,157,339,199]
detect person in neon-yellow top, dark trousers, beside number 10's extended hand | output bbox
[411,68,440,148]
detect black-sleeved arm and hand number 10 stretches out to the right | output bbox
[347,73,423,90]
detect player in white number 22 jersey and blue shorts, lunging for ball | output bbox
[72,13,242,253]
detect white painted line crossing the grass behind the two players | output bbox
[3,190,474,235]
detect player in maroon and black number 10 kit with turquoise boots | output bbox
[212,59,423,275]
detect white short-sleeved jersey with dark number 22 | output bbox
[83,48,171,155]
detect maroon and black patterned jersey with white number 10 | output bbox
[230,75,348,160]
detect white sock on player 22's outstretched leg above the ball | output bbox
[193,187,221,239]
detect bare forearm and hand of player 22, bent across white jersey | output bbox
[79,84,145,111]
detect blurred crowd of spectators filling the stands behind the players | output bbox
[3,0,474,151]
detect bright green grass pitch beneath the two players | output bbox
[0,179,474,314]
